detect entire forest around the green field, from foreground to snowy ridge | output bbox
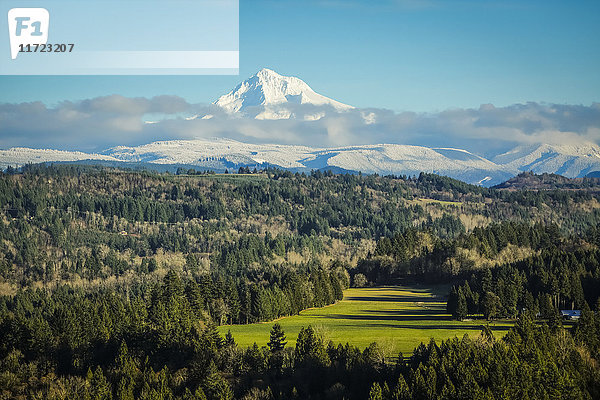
[0,165,600,400]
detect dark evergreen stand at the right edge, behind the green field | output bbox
[447,248,600,319]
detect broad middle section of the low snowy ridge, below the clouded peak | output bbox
[108,139,513,184]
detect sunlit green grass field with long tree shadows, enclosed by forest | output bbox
[219,286,513,355]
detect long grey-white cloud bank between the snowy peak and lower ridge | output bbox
[0,95,600,156]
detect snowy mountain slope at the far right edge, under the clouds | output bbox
[493,143,600,178]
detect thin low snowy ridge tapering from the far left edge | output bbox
[0,147,118,169]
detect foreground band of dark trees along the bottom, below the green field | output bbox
[0,311,600,400]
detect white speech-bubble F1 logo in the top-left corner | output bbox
[8,8,50,60]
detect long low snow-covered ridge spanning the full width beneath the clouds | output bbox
[0,139,600,186]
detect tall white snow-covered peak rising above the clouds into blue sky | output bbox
[214,68,353,119]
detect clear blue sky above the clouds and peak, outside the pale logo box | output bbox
[0,0,600,112]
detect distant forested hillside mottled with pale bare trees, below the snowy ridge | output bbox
[0,162,600,289]
